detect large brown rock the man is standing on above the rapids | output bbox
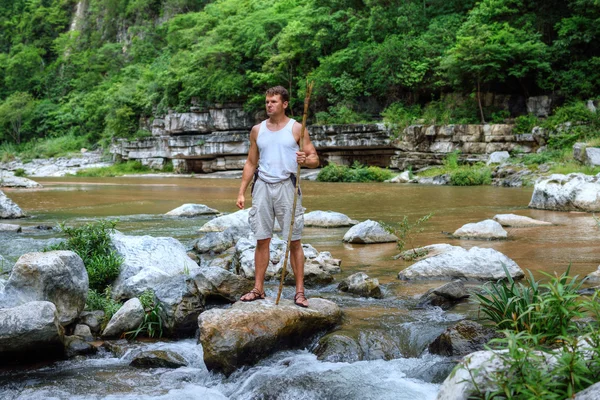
[198,298,342,374]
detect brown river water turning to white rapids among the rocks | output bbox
[0,177,600,400]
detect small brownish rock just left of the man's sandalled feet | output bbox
[194,267,254,302]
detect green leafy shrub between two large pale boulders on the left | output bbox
[47,220,123,292]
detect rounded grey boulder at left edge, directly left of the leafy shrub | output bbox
[0,251,89,325]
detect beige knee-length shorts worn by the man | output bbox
[248,179,304,240]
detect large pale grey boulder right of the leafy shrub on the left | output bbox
[111,232,200,299]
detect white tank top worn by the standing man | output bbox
[256,119,300,183]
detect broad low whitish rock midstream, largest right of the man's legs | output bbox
[398,246,524,280]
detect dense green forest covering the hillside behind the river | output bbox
[0,0,600,155]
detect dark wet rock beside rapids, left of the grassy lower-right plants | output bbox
[429,320,499,357]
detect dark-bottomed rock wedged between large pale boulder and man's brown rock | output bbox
[154,275,204,337]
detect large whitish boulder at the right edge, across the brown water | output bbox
[529,173,600,212]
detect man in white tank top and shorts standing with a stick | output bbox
[236,86,319,307]
